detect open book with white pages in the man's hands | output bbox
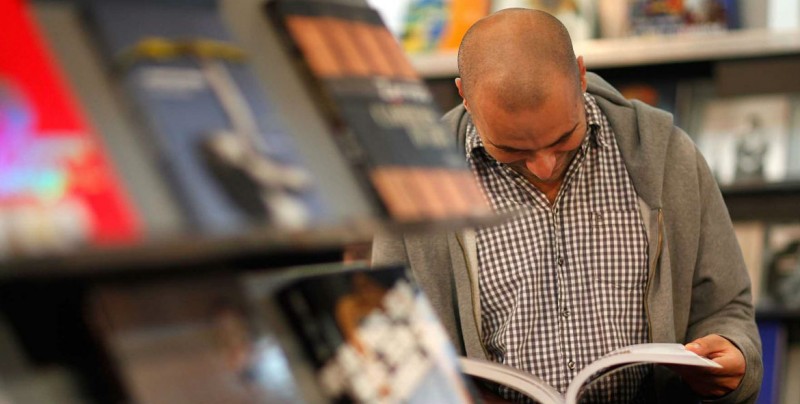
[460,343,721,404]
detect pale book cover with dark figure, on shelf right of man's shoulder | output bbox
[696,94,790,186]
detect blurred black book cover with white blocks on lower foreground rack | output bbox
[245,266,474,403]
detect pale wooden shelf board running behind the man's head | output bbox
[410,30,800,78]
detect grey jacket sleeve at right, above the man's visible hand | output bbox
[686,148,763,403]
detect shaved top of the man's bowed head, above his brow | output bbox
[458,8,581,110]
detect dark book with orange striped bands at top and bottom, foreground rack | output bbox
[266,0,489,222]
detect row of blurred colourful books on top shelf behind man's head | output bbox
[380,0,800,53]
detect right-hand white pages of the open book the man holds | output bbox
[566,344,722,404]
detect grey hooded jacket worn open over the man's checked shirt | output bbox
[373,73,762,403]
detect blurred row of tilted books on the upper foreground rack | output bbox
[0,0,490,268]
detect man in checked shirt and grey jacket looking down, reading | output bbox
[373,9,762,403]
